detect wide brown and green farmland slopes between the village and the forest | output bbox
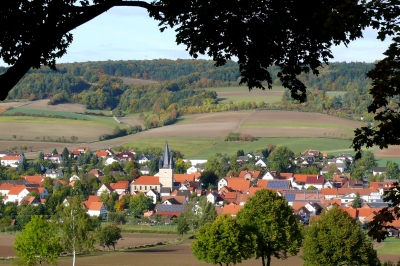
[0,101,400,160]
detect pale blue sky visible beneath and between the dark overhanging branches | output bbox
[0,7,389,66]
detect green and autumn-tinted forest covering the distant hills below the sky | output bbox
[0,59,382,128]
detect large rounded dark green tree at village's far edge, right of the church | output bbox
[268,146,295,174]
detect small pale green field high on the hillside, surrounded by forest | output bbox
[207,86,284,103]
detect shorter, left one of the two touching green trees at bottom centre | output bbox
[190,214,257,266]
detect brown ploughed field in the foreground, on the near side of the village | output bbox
[0,234,399,266]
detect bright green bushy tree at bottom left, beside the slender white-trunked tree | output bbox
[14,216,62,265]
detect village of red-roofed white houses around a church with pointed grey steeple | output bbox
[0,142,400,234]
